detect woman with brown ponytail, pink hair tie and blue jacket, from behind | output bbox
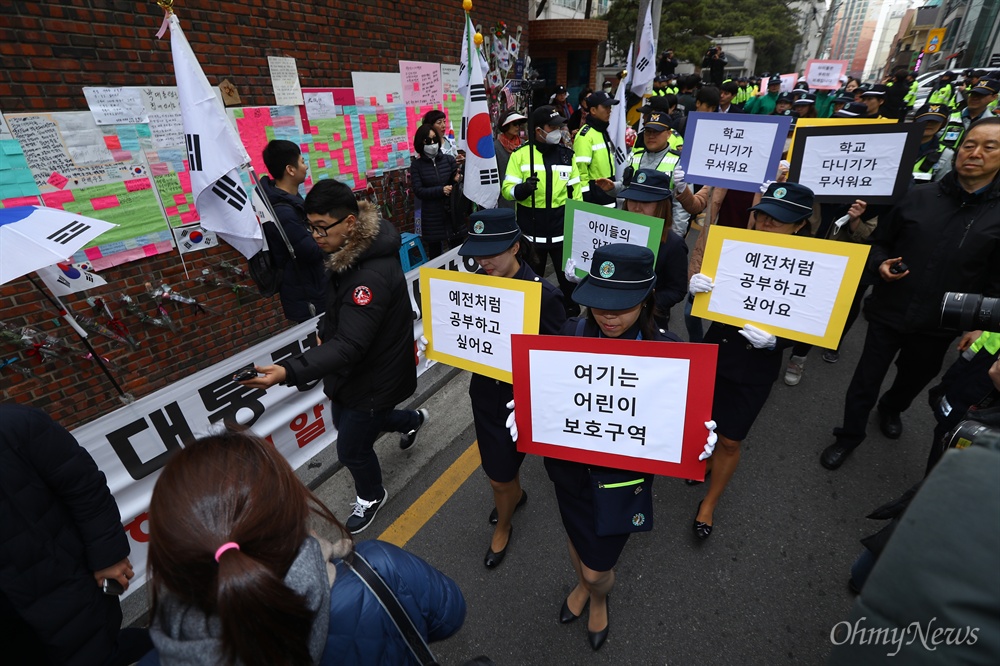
[141,431,465,666]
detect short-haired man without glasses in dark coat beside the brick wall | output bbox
[260,139,327,322]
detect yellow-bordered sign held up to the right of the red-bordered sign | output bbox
[691,226,870,349]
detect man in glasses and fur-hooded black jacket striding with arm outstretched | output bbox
[244,180,428,534]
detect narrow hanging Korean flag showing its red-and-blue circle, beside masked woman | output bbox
[460,44,500,208]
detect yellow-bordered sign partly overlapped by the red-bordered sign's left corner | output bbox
[420,268,542,384]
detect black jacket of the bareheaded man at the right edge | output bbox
[865,171,1000,337]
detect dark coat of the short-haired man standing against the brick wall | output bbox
[260,176,327,321]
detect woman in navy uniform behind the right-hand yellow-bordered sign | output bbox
[689,183,813,539]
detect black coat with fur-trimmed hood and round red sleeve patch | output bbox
[280,202,417,410]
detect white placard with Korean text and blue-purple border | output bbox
[680,113,792,192]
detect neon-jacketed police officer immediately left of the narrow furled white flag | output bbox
[573,91,625,206]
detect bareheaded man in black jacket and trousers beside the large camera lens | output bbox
[820,118,1000,470]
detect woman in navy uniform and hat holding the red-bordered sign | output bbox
[536,244,715,650]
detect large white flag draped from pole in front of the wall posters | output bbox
[170,14,262,258]
